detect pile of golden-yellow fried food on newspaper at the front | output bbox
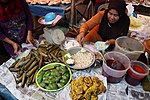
[70,76,106,100]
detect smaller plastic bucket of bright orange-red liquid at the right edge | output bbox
[125,61,149,86]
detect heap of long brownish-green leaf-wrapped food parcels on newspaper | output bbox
[9,42,64,87]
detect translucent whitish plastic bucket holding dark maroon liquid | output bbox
[102,51,130,83]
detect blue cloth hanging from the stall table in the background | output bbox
[28,4,71,16]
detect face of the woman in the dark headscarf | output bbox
[107,9,119,24]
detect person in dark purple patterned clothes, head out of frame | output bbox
[0,0,34,56]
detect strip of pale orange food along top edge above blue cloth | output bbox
[26,0,71,5]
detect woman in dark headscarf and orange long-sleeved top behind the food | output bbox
[77,0,130,44]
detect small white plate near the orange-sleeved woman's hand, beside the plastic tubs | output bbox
[95,41,109,51]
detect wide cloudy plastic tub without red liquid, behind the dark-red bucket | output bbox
[114,36,145,60]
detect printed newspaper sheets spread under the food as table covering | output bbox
[0,58,150,100]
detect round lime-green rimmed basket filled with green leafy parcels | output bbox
[36,63,72,91]
